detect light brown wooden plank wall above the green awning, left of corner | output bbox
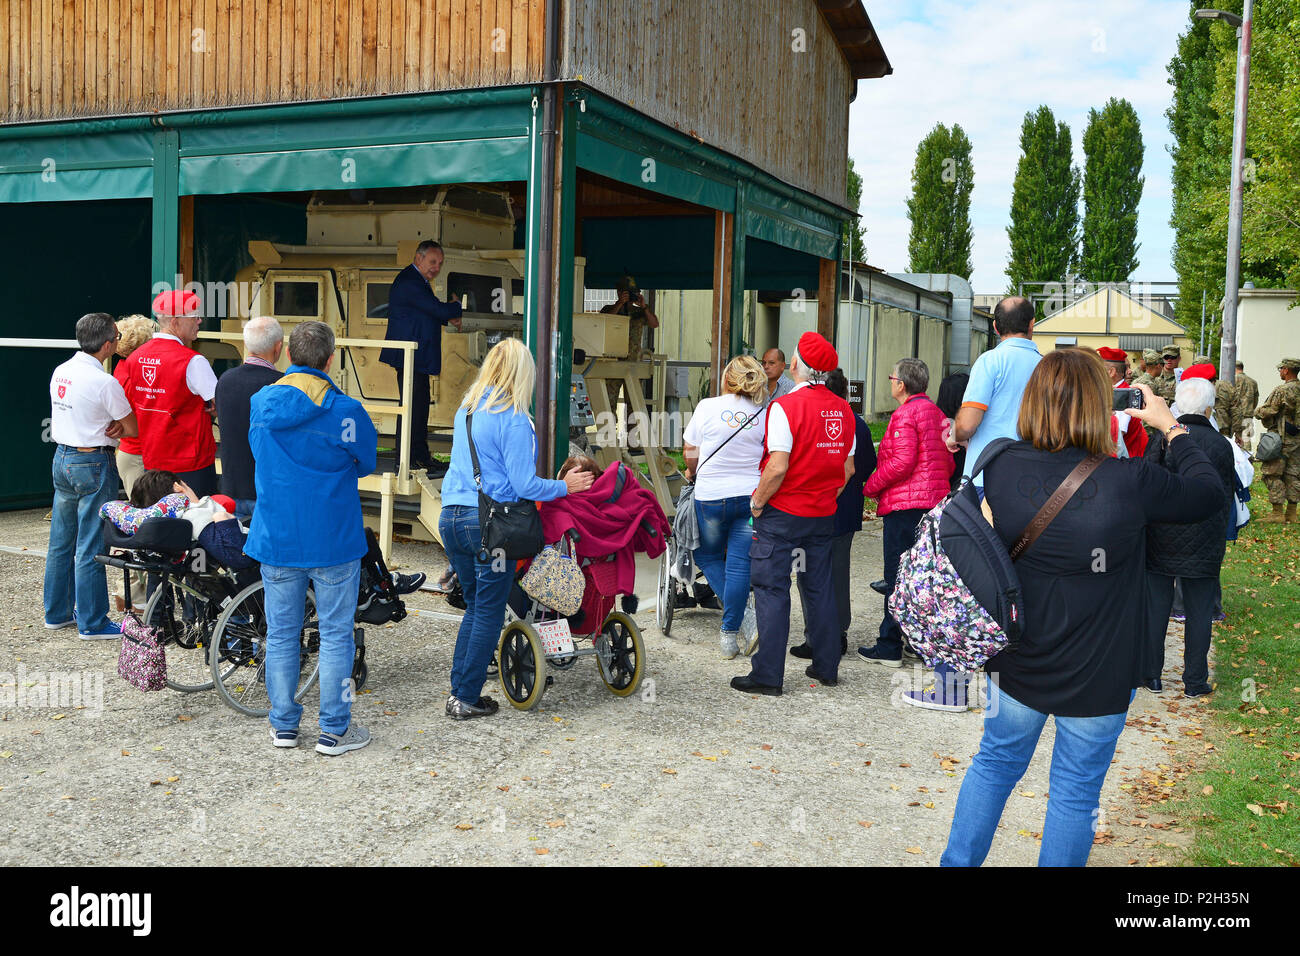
[0,0,546,122]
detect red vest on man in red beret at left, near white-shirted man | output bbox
[122,338,217,472]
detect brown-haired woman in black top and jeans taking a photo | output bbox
[940,349,1223,866]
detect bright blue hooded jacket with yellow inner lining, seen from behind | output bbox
[244,365,378,567]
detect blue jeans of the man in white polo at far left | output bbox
[44,445,117,633]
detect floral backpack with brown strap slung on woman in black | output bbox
[889,438,1102,671]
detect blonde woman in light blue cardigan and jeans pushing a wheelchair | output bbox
[438,338,593,721]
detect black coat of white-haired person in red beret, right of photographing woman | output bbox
[1144,415,1236,578]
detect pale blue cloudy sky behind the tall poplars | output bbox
[849,0,1196,293]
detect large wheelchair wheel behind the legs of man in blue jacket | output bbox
[209,581,320,717]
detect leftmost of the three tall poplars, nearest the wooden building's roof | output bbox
[907,124,975,280]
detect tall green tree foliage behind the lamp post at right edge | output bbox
[1166,0,1300,355]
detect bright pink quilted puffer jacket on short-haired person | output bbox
[866,395,953,515]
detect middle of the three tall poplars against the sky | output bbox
[1006,107,1079,299]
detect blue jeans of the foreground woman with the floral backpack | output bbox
[939,680,1132,866]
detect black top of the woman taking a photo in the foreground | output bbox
[984,437,1223,717]
